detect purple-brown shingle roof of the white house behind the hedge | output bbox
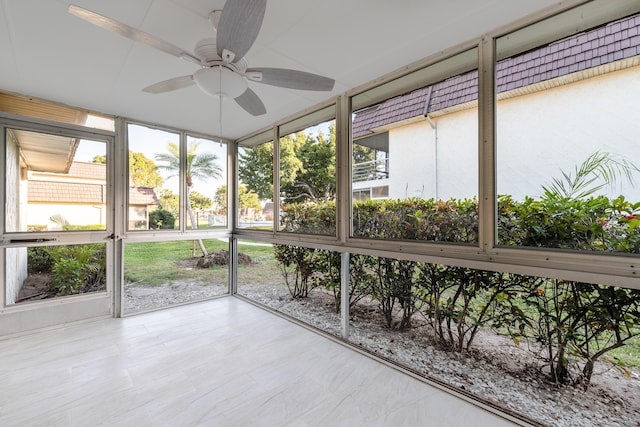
[353,14,640,138]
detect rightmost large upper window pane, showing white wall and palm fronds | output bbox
[496,8,640,254]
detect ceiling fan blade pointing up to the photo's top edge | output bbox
[216,0,267,62]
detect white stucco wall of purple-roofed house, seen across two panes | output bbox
[389,67,640,201]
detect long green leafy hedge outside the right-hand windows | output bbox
[275,196,640,385]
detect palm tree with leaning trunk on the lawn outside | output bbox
[155,141,222,256]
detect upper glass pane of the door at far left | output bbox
[5,129,107,232]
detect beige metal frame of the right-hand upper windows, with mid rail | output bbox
[233,0,640,289]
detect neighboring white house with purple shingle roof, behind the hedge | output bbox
[352,11,640,200]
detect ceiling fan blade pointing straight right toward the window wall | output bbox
[245,68,335,91]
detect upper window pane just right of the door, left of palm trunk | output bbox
[127,124,181,230]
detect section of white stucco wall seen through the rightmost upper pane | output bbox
[497,67,640,201]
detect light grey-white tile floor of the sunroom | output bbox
[0,297,524,427]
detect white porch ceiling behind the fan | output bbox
[0,0,558,139]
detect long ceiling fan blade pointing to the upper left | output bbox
[68,4,201,65]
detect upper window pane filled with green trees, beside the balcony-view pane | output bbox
[279,114,336,235]
